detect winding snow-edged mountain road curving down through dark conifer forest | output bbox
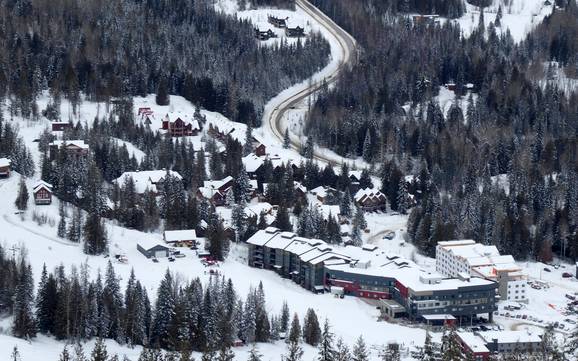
[263,0,357,165]
